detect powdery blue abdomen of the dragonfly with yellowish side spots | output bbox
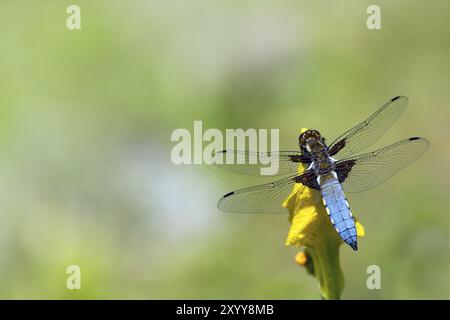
[317,171,358,251]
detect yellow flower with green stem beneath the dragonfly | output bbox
[283,129,364,300]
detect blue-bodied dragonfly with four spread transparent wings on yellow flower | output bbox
[214,96,430,251]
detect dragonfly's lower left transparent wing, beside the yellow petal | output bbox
[217,175,302,213]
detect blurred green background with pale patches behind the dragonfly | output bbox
[0,0,450,299]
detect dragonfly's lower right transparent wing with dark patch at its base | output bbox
[335,137,430,192]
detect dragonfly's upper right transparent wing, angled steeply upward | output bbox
[330,96,408,159]
